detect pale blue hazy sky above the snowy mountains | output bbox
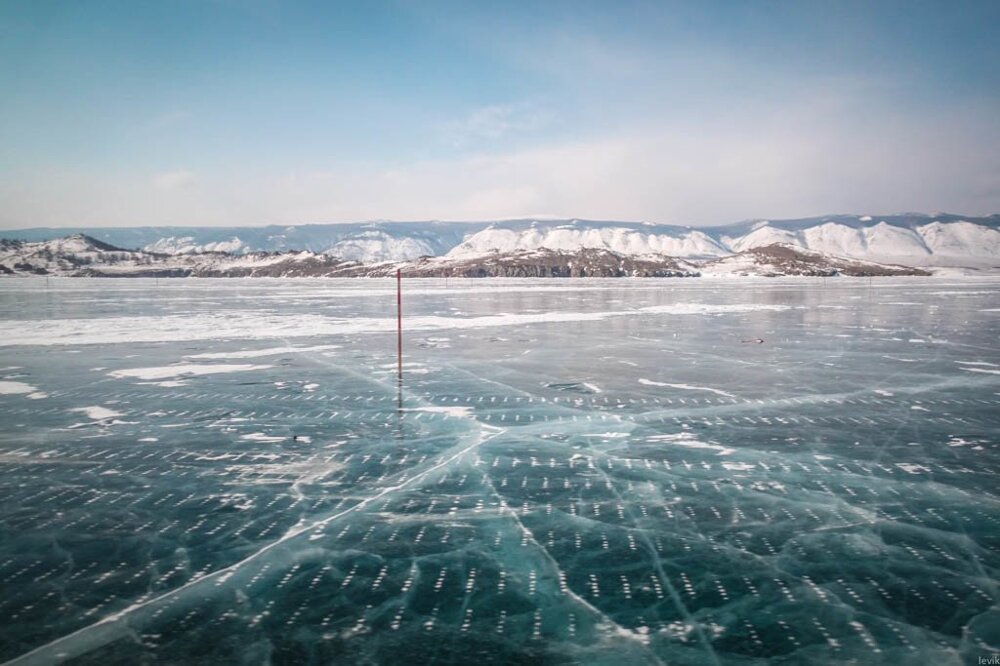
[0,0,1000,228]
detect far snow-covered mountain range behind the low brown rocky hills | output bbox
[0,213,1000,268]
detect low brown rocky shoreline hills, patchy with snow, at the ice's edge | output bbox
[0,234,944,278]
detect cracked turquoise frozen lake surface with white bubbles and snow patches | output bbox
[0,278,1000,665]
